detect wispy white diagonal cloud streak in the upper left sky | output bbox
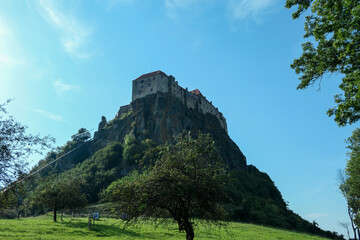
[40,0,92,58]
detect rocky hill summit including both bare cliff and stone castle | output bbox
[93,71,246,170]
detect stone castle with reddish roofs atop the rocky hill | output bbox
[116,71,227,132]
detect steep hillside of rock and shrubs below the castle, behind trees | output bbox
[28,92,341,239]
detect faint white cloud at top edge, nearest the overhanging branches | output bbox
[228,0,277,21]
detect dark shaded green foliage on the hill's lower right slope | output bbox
[224,168,343,239]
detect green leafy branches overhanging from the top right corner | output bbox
[285,0,360,126]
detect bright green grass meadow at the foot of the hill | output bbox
[0,215,325,240]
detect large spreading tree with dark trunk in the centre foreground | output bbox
[104,134,226,240]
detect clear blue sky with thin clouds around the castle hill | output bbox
[0,0,354,236]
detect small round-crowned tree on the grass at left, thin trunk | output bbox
[35,175,86,222]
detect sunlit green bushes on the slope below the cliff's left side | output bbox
[28,134,154,207]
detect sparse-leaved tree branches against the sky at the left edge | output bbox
[0,100,54,187]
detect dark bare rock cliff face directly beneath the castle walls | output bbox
[92,92,246,170]
